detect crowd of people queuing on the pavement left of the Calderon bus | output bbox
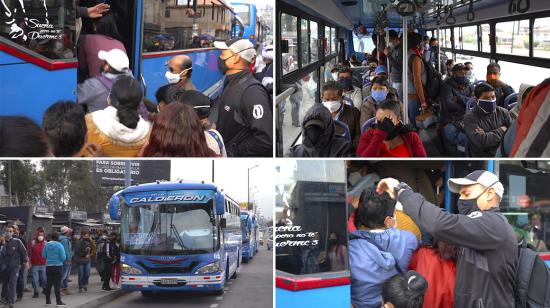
[0,225,121,308]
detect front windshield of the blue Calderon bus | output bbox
[122,201,217,255]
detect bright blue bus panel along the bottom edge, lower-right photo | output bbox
[276,285,351,308]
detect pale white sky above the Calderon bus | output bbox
[170,158,275,218]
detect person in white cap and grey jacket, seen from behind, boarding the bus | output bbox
[76,49,132,112]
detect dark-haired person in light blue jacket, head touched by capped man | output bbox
[349,188,419,308]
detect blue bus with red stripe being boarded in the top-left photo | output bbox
[0,0,242,123]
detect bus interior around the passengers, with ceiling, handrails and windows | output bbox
[276,0,550,157]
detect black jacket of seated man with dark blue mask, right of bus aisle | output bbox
[462,105,512,157]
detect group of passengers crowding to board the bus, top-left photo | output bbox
[0,6,273,157]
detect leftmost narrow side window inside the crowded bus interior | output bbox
[280,13,298,75]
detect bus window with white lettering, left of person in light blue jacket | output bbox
[275,160,348,275]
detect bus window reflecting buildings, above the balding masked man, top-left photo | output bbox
[143,0,232,52]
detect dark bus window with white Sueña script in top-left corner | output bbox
[0,0,76,59]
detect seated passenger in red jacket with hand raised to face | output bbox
[357,99,426,157]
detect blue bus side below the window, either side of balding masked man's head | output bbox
[142,50,223,102]
